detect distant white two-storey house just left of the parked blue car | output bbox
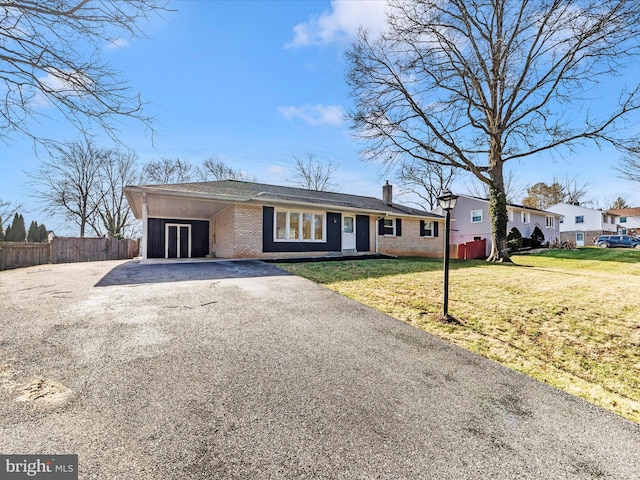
[547,203,618,247]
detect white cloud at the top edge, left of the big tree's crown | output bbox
[287,0,387,47]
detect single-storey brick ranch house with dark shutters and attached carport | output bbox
[124,180,444,259]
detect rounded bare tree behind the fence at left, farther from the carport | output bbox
[27,138,108,237]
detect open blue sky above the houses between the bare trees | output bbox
[0,0,640,234]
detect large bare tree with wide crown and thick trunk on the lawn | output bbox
[347,0,640,261]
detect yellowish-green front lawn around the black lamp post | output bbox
[279,248,640,423]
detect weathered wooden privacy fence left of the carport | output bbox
[0,237,138,270]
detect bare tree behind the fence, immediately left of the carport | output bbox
[89,149,140,238]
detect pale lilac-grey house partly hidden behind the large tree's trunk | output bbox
[433,195,560,255]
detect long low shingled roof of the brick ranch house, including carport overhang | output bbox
[124,180,443,219]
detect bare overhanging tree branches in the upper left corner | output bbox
[0,0,167,143]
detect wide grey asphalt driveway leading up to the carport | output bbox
[0,262,640,480]
